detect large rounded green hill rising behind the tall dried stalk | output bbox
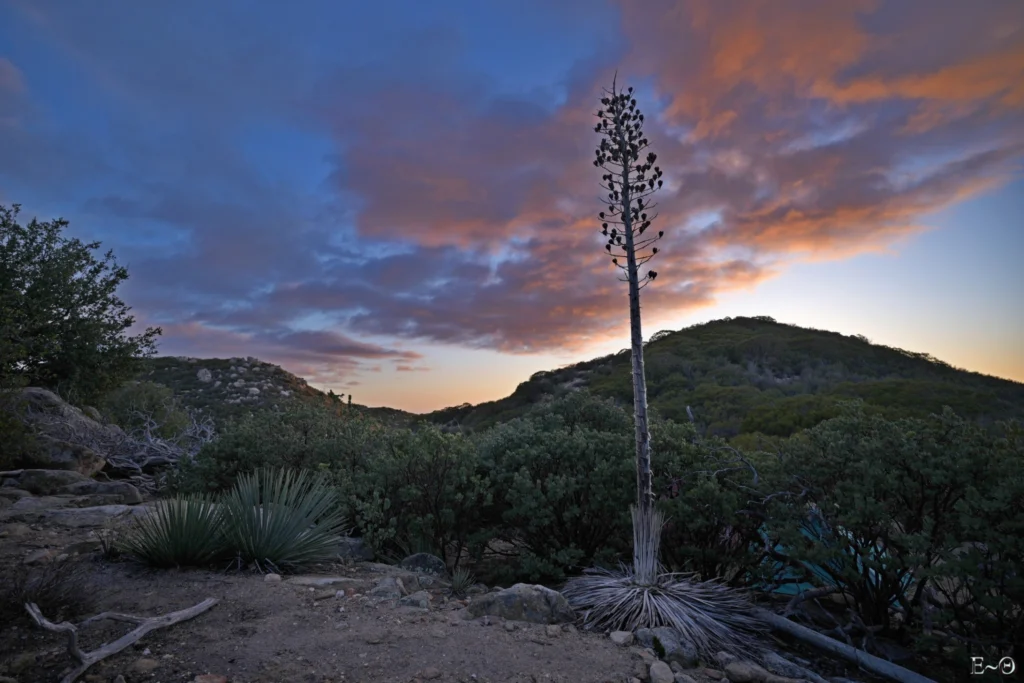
[424,316,1024,438]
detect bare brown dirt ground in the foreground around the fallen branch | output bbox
[0,509,869,683]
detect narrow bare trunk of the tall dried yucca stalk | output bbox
[615,93,660,584]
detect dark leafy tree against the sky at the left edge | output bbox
[0,204,162,402]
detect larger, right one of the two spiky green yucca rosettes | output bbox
[223,469,345,571]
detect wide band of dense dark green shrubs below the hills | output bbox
[169,391,1024,675]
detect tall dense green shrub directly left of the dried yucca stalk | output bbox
[477,391,636,581]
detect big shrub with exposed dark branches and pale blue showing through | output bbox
[771,409,1021,640]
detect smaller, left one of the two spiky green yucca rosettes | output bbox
[119,496,224,567]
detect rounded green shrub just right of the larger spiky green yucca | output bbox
[355,425,492,566]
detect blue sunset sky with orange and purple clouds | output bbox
[0,0,1024,413]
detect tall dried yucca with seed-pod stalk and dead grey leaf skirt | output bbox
[562,74,762,658]
